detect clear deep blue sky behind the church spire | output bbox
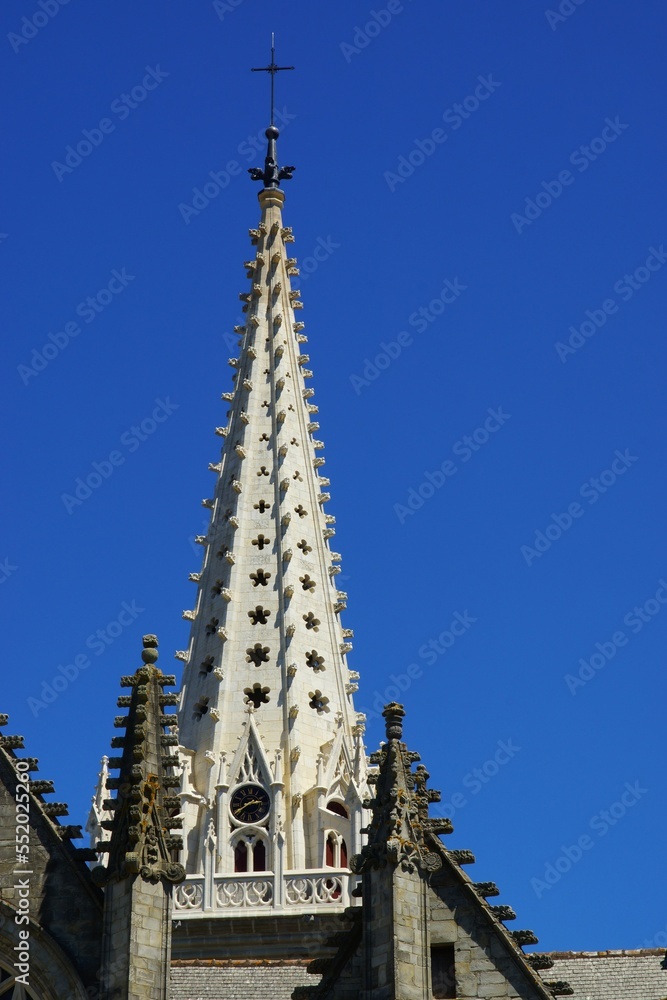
[0,0,667,950]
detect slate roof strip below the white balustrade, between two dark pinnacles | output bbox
[171,959,318,1000]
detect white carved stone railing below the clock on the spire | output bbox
[174,868,351,919]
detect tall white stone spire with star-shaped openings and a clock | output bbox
[175,158,366,917]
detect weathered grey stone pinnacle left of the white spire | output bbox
[91,635,185,1000]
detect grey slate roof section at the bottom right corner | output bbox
[545,948,667,1000]
